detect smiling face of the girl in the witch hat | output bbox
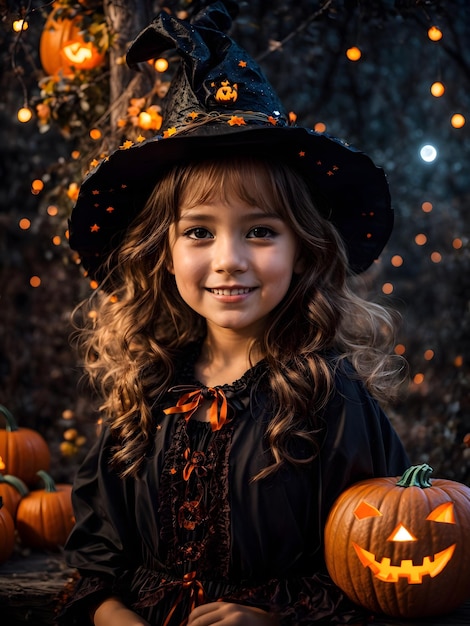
[169,193,301,338]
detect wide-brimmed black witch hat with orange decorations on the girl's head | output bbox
[69,0,393,278]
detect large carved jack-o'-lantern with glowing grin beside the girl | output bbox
[325,465,470,618]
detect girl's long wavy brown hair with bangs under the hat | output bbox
[72,157,404,477]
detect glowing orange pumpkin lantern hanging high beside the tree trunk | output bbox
[39,3,106,76]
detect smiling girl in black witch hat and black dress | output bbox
[61,2,408,626]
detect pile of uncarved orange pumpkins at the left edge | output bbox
[0,405,74,563]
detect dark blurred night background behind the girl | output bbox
[0,0,470,484]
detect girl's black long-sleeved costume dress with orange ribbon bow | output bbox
[59,348,408,626]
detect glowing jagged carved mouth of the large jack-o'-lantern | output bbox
[352,541,456,585]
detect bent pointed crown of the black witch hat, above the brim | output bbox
[127,0,287,129]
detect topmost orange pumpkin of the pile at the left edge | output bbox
[0,405,51,486]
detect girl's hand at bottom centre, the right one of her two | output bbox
[188,602,279,626]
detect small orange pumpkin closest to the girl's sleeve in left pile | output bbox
[16,471,74,550]
